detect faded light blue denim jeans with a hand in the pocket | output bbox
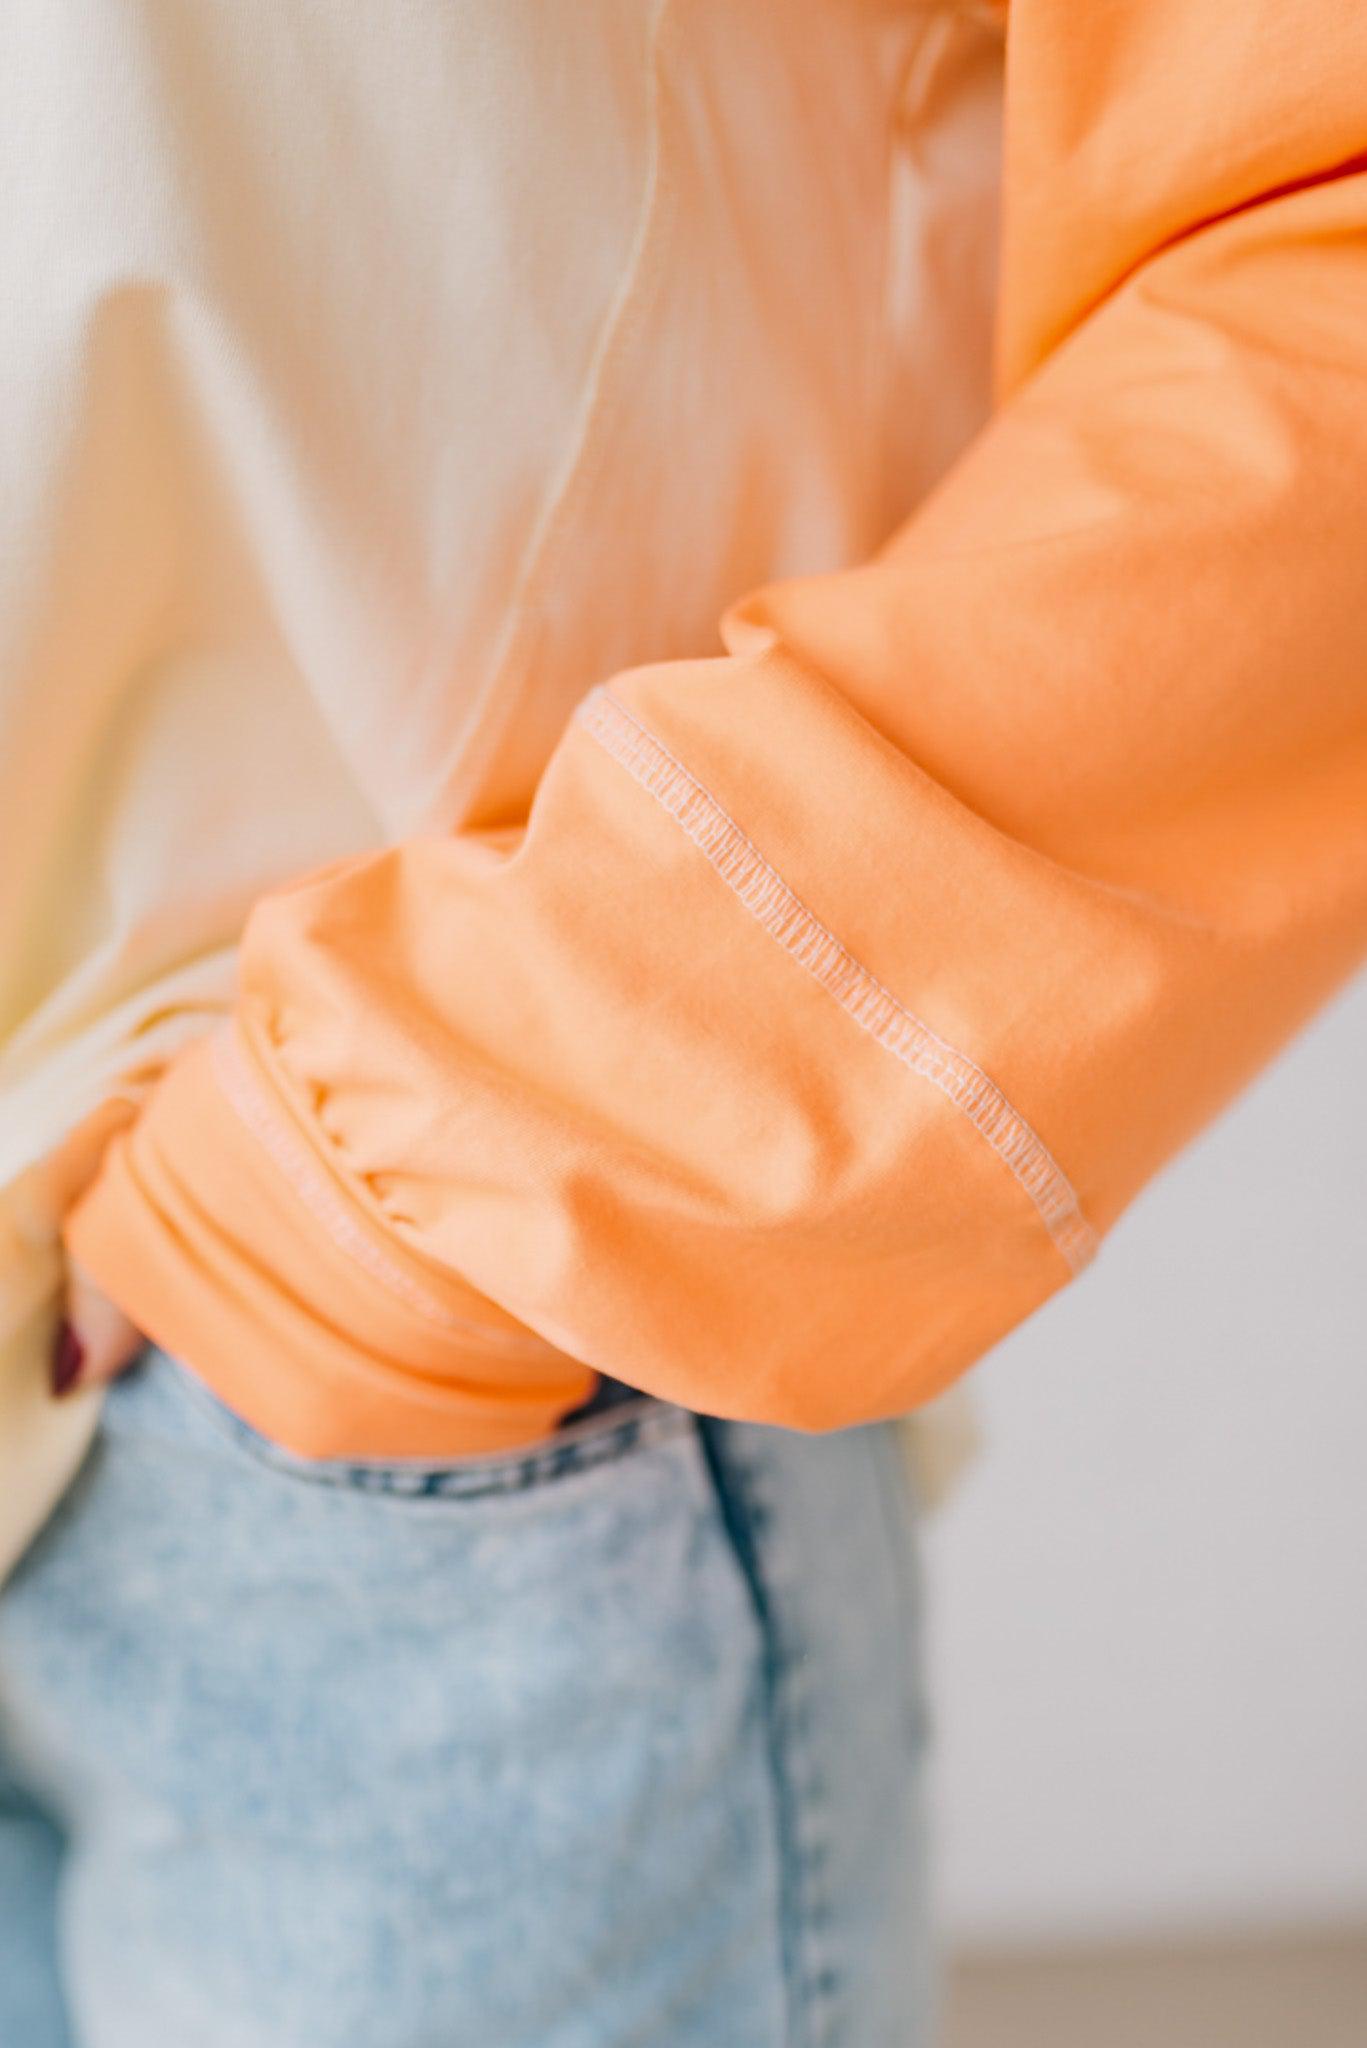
[0,1350,930,2048]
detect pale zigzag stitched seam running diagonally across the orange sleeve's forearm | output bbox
[576,688,1096,1272]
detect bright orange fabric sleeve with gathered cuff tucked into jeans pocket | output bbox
[68,0,1367,1450]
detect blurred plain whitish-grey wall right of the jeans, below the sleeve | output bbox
[926,981,1367,1942]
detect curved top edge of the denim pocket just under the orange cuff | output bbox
[133,1346,693,1503]
